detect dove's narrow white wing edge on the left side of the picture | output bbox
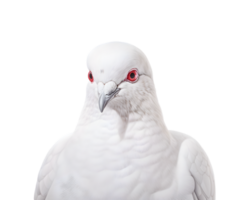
[33,132,71,200]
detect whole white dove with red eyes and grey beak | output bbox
[33,41,216,200]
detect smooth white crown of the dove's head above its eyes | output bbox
[86,41,152,85]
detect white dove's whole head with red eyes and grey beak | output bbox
[86,41,156,113]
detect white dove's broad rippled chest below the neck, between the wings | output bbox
[52,131,180,200]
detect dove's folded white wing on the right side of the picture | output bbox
[181,138,216,200]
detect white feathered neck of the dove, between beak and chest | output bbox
[75,89,170,142]
